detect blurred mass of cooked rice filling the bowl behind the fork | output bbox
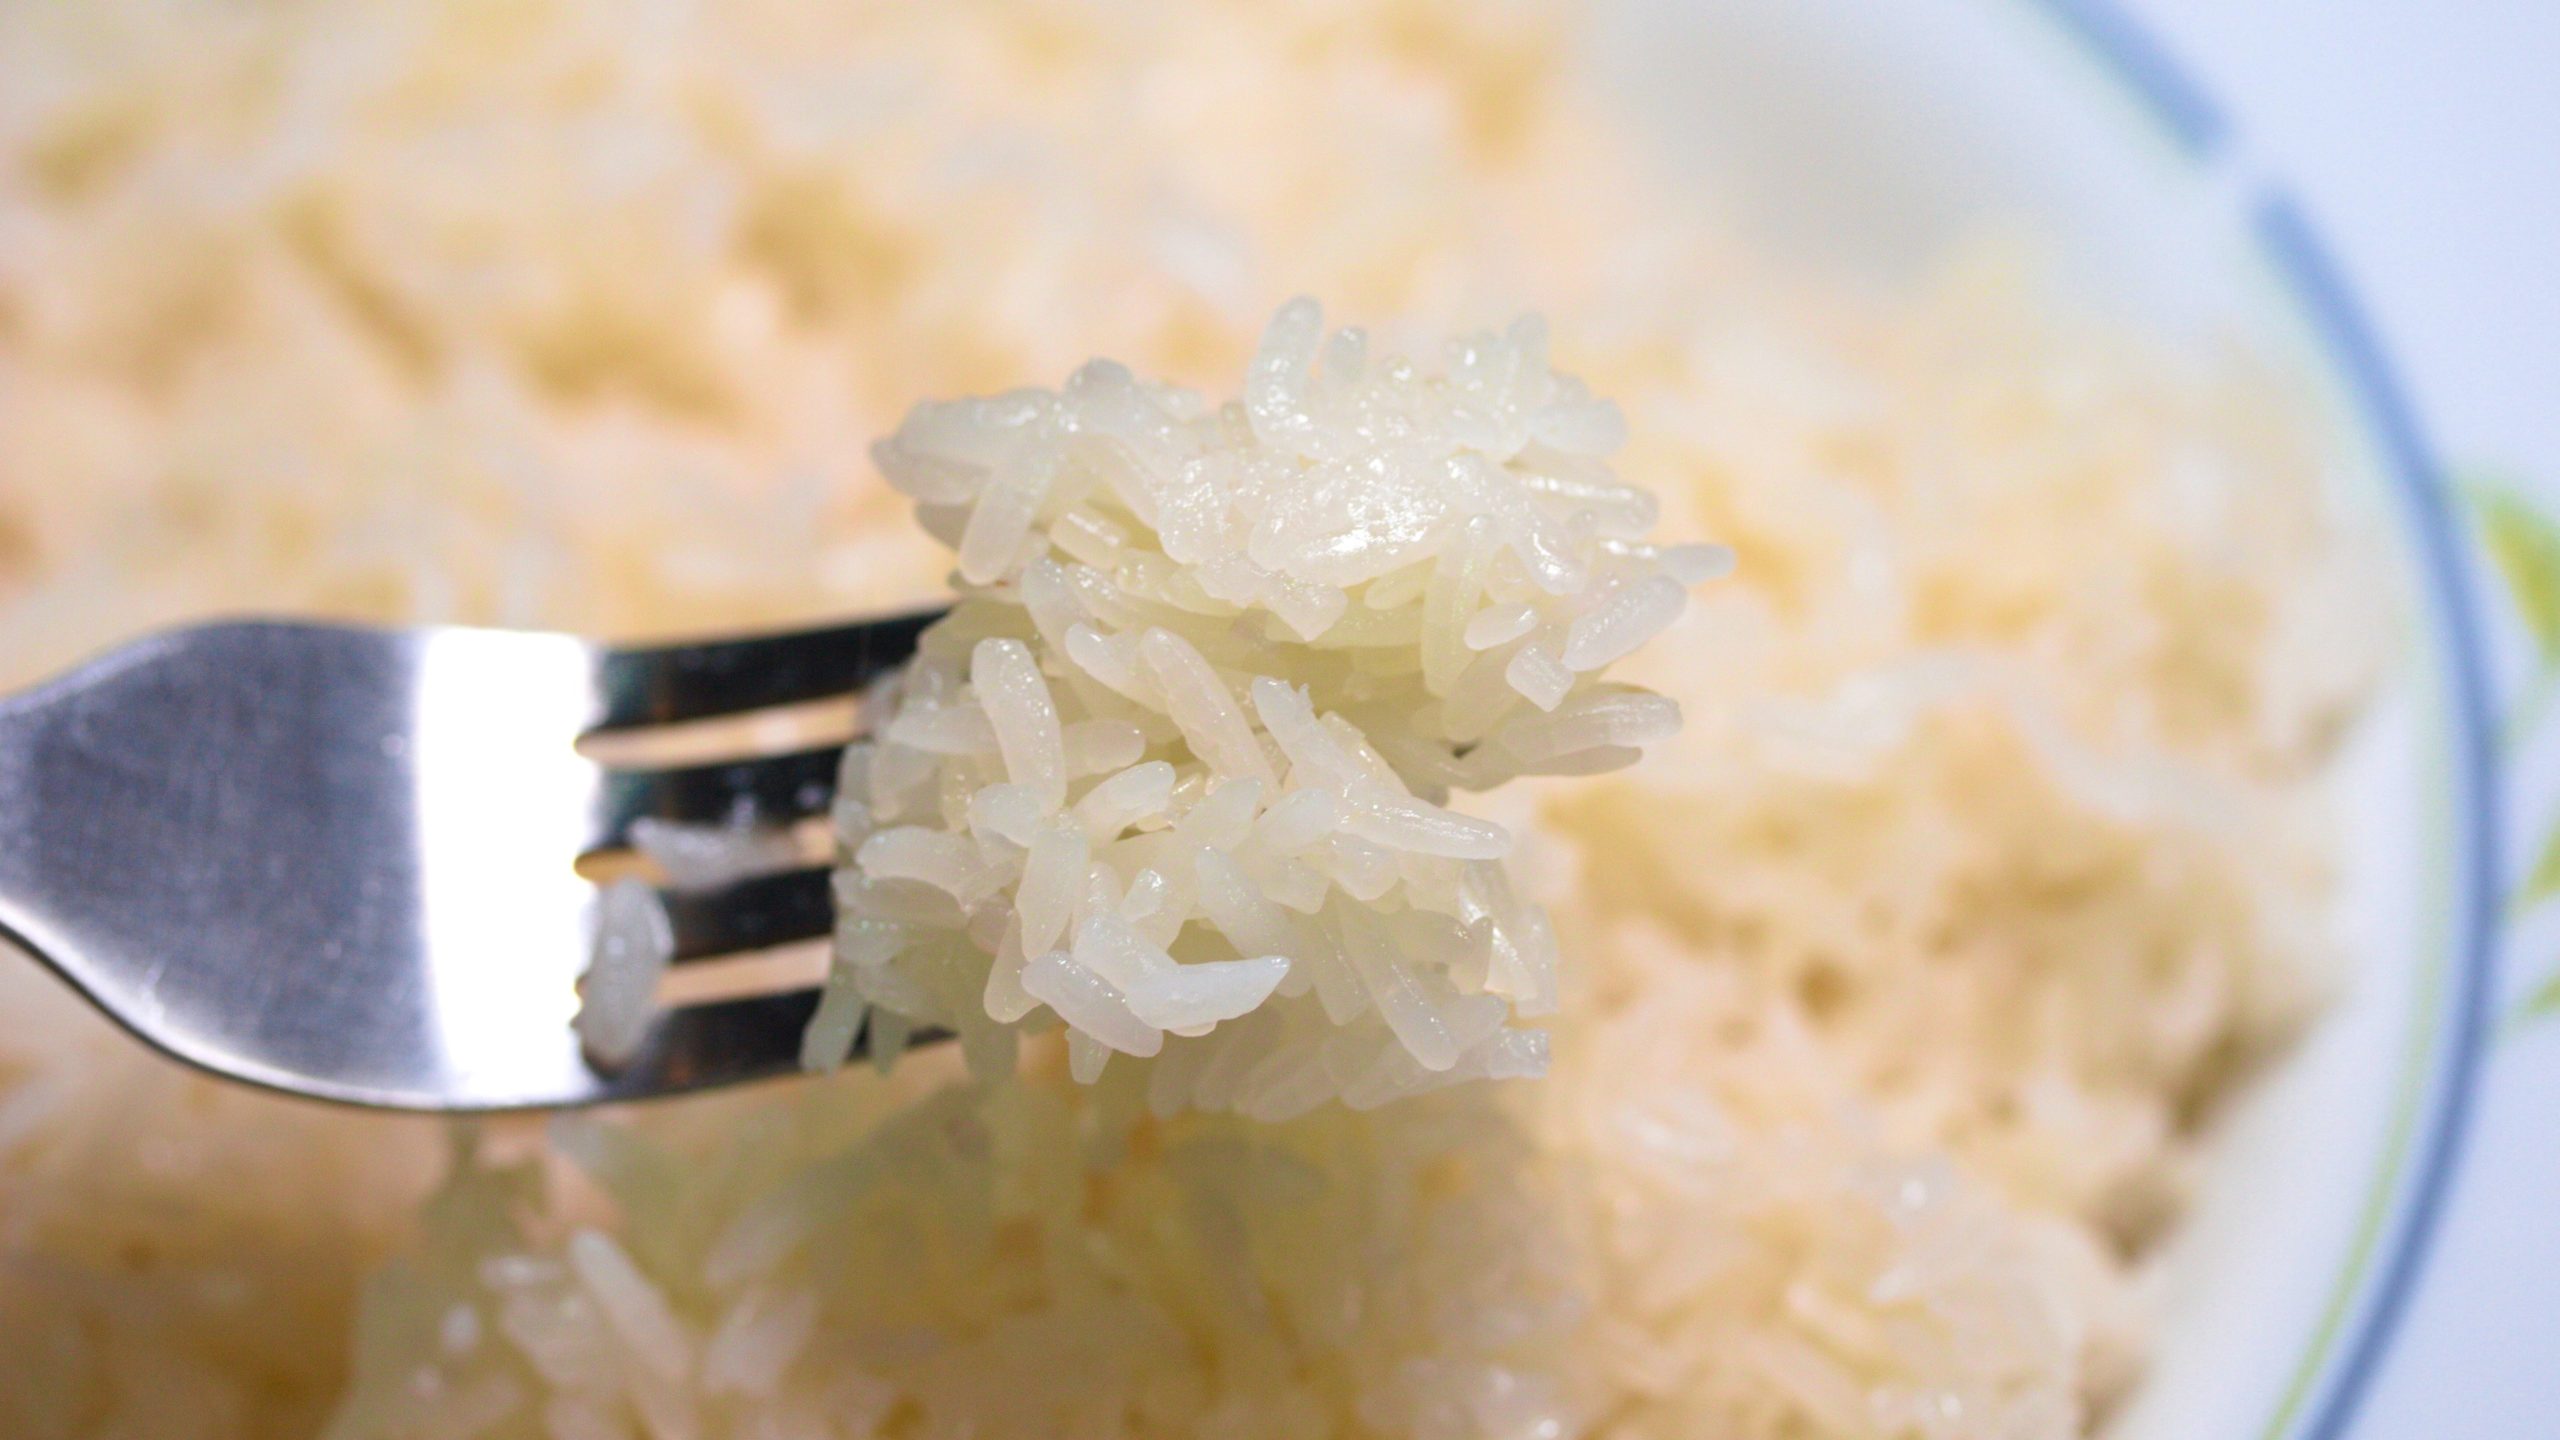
[0,0,2360,1440]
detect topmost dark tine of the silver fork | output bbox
[594,610,942,733]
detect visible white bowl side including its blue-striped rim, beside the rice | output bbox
[1595,0,2499,1440]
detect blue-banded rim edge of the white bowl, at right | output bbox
[2022,0,2506,1440]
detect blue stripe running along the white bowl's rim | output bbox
[1996,0,2506,1440]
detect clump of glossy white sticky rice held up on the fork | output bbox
[804,300,1728,1120]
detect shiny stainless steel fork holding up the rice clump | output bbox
[0,612,940,1112]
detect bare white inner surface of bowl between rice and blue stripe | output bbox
[1592,0,2463,1440]
